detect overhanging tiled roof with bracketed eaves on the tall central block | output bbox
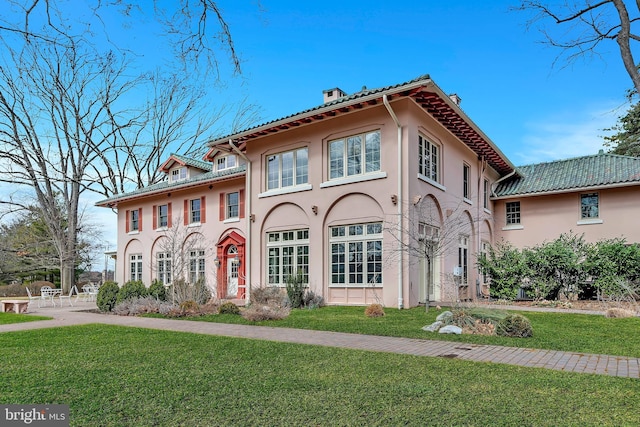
[209,74,515,175]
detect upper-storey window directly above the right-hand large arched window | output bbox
[329,130,380,179]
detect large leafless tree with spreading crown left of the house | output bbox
[0,0,254,291]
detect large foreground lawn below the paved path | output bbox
[0,324,640,426]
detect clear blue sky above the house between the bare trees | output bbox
[87,0,631,262]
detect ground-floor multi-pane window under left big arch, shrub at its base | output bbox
[267,229,309,286]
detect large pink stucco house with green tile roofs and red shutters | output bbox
[98,76,640,308]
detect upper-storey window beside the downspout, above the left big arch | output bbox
[267,147,309,190]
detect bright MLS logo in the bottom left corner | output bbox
[0,405,69,427]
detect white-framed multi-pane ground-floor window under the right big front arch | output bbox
[329,222,382,286]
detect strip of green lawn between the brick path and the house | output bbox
[176,306,640,357]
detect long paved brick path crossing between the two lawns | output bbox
[0,302,640,378]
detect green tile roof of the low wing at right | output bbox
[494,152,640,198]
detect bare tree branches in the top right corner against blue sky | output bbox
[516,0,640,93]
